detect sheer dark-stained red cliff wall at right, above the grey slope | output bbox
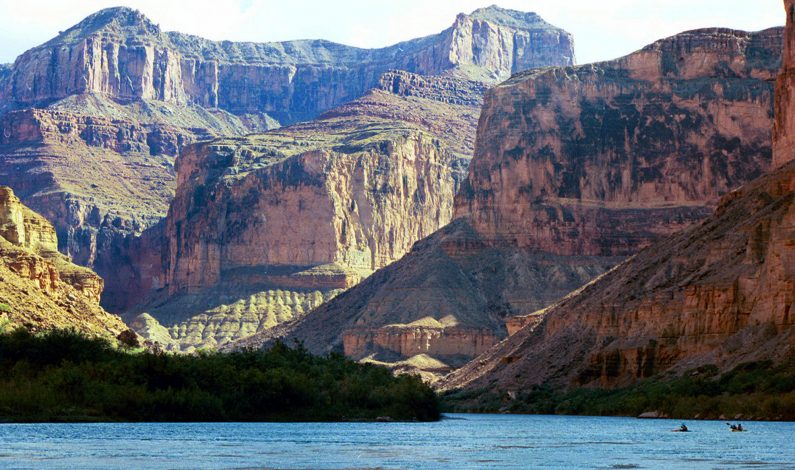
[456,29,782,256]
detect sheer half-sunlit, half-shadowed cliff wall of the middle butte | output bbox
[166,127,454,293]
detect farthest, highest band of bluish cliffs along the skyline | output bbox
[0,7,574,123]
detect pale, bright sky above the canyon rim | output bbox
[0,0,785,64]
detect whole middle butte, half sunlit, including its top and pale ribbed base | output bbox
[130,86,477,350]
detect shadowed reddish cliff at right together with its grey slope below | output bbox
[244,29,783,374]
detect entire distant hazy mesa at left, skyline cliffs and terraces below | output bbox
[0,7,574,320]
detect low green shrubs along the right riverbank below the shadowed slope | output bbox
[442,359,795,421]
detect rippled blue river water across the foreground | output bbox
[0,414,795,470]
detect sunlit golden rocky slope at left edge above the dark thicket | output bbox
[0,186,127,338]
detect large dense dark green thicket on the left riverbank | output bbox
[0,329,439,421]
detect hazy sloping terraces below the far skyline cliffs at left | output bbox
[0,101,270,307]
